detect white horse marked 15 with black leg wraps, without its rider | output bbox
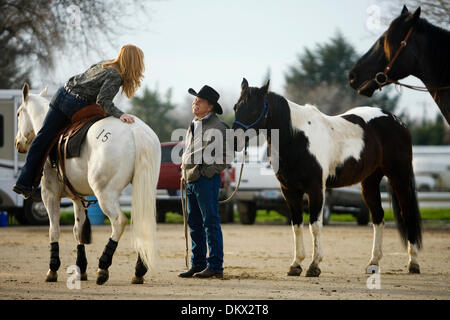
[15,84,161,284]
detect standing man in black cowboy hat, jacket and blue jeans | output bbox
[179,85,230,278]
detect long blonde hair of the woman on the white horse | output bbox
[102,44,145,98]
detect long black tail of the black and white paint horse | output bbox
[390,174,422,249]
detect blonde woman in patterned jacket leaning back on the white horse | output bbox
[13,45,140,198]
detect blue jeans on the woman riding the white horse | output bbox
[17,87,88,188]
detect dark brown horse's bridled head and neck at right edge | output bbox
[349,6,450,123]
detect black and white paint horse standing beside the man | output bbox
[233,79,421,277]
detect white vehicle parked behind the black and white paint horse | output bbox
[232,145,369,225]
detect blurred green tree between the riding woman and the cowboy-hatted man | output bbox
[130,87,180,142]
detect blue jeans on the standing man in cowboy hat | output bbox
[186,174,223,272]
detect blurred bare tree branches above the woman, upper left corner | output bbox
[0,0,151,88]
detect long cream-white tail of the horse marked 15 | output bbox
[129,119,161,271]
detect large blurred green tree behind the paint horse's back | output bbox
[285,32,404,116]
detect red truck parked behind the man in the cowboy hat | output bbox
[156,142,235,223]
